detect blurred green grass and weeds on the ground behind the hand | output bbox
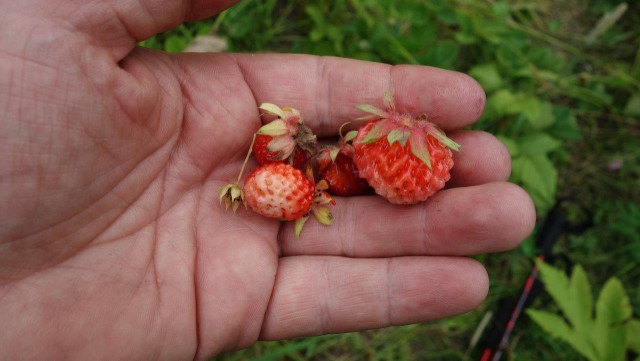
[143,0,640,361]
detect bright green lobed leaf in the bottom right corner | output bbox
[527,262,638,361]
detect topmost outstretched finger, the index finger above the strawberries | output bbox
[237,54,485,136]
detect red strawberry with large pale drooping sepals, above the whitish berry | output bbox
[252,103,316,169]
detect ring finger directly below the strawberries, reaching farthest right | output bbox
[280,182,535,257]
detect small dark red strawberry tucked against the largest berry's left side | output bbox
[318,124,369,197]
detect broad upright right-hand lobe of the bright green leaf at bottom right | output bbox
[593,277,631,361]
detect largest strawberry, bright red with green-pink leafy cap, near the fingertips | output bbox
[353,95,460,204]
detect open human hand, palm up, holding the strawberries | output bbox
[0,0,534,359]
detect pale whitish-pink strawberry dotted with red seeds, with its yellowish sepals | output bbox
[242,162,333,235]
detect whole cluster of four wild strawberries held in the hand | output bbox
[220,94,460,236]
